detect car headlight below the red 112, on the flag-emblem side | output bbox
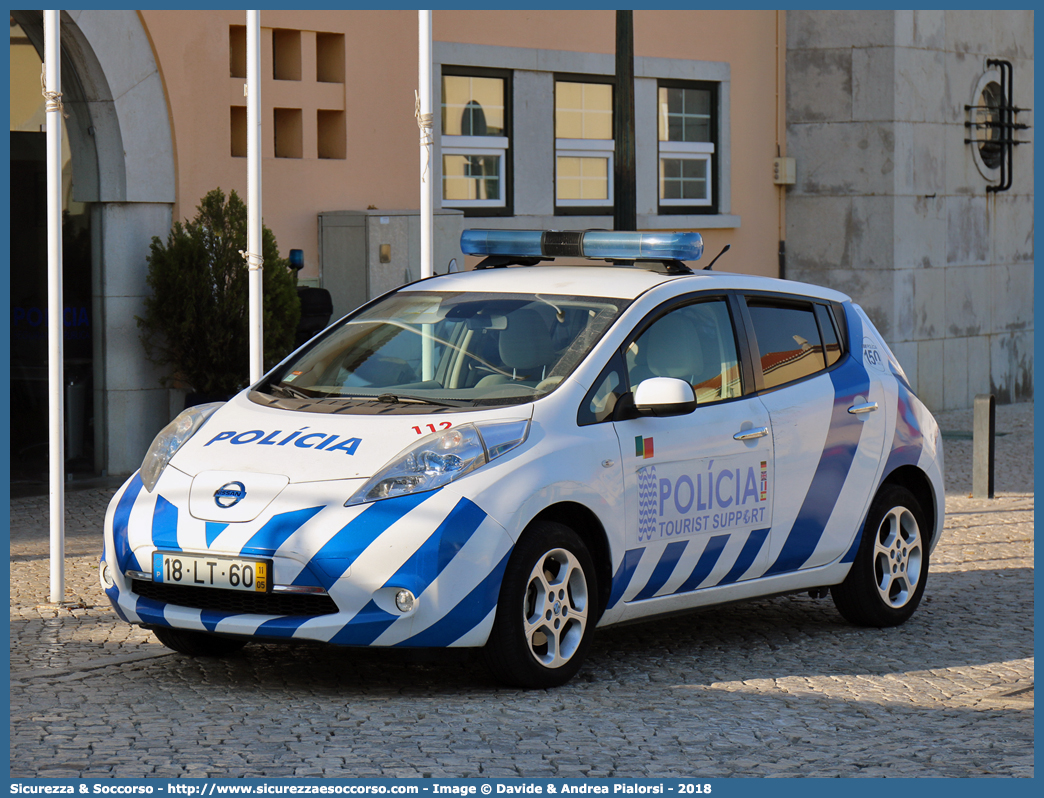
[345,419,529,507]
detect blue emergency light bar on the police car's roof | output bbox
[460,230,704,261]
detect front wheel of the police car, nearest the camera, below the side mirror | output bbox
[485,521,598,688]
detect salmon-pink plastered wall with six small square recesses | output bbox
[141,10,782,278]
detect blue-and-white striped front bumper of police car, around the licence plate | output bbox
[102,469,512,647]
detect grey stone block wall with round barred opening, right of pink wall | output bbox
[786,10,1035,410]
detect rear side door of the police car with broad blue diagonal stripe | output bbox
[744,295,886,576]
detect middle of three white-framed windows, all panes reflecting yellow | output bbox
[554,78,615,210]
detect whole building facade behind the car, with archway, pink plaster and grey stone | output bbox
[10,10,1033,474]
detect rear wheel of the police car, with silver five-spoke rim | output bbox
[830,485,928,628]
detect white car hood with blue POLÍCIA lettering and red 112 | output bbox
[170,394,532,483]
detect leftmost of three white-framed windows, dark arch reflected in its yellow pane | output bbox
[442,67,511,212]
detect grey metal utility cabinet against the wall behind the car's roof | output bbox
[319,210,464,320]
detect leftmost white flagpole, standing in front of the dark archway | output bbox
[44,11,65,604]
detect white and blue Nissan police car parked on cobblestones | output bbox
[101,231,944,686]
